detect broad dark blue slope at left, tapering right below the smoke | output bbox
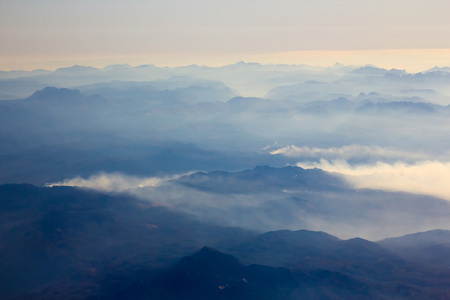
[0,185,253,298]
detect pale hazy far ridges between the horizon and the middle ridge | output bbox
[0,62,450,184]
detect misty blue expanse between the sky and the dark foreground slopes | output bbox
[0,62,450,239]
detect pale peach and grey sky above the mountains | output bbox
[0,0,450,70]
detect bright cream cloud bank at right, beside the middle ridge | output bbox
[297,159,450,200]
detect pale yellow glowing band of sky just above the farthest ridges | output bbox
[0,49,450,73]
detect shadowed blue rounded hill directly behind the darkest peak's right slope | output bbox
[223,230,442,287]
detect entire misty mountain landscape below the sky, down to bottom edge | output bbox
[0,62,450,299]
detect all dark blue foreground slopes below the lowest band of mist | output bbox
[0,185,450,299]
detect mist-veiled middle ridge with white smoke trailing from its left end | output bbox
[48,166,450,240]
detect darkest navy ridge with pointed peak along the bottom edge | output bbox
[100,248,448,299]
